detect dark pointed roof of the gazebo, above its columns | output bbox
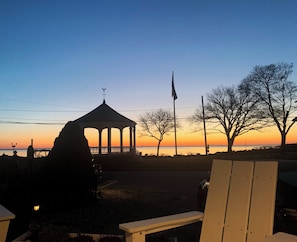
[75,100,136,130]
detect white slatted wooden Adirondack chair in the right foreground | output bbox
[119,160,297,242]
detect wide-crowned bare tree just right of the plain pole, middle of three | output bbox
[191,87,264,152]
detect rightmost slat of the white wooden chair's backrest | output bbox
[247,161,278,242]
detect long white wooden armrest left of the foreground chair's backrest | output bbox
[119,211,203,234]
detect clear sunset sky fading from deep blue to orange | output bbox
[0,0,297,151]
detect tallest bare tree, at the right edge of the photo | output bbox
[241,63,297,151]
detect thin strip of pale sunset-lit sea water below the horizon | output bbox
[0,145,272,157]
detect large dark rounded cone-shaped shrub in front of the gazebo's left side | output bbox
[43,122,94,209]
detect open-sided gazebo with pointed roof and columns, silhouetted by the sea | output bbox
[74,99,136,154]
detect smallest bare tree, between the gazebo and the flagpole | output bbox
[139,109,174,156]
